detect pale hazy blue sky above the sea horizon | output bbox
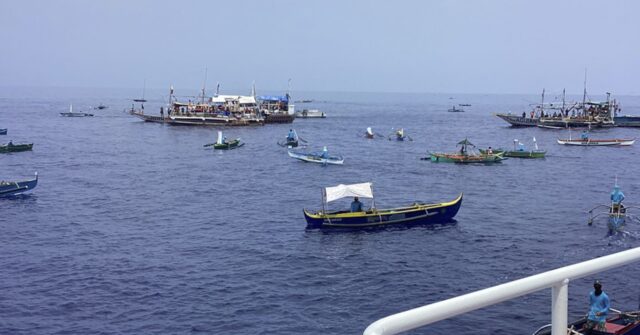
[0,0,640,94]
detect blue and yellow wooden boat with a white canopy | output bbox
[303,183,462,229]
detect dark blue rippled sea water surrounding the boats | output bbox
[0,89,640,334]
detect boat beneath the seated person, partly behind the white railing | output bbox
[533,308,640,335]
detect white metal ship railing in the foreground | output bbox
[364,248,640,335]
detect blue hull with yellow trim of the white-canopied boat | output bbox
[304,194,462,229]
